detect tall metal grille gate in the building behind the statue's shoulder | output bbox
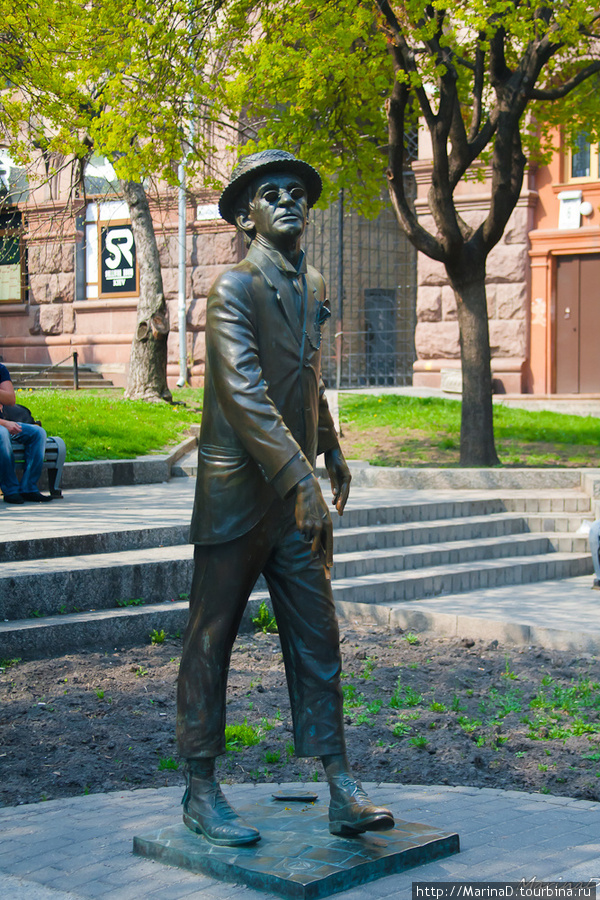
[305,185,417,388]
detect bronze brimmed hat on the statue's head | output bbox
[219,150,323,225]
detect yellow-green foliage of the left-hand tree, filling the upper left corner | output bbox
[0,0,230,184]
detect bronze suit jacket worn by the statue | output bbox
[190,238,338,544]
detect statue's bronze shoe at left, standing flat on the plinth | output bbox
[182,773,260,847]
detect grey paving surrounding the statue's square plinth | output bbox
[0,783,600,900]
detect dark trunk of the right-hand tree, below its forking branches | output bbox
[448,260,500,466]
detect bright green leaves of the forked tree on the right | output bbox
[215,0,600,216]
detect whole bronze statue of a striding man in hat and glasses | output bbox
[177,150,394,846]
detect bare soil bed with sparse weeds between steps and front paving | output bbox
[0,624,600,806]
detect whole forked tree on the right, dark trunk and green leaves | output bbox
[216,0,600,465]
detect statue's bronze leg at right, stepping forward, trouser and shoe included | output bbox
[264,506,394,836]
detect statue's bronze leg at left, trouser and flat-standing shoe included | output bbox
[177,526,269,846]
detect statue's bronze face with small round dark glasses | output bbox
[247,172,308,250]
